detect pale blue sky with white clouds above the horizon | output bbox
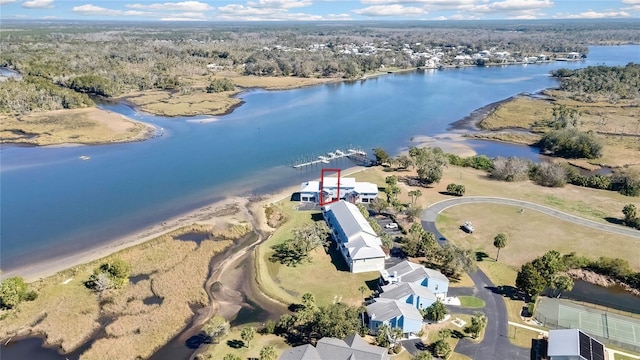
[0,0,640,21]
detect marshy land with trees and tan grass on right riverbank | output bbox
[456,63,640,170]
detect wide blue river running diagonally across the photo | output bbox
[0,46,640,271]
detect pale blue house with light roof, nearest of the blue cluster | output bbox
[367,298,422,336]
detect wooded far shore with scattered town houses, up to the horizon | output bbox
[0,20,640,116]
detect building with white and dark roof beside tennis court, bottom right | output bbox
[547,329,605,360]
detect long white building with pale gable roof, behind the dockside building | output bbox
[322,200,386,273]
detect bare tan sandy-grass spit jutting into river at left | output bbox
[0,108,153,145]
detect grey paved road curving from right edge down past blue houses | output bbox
[421,196,640,360]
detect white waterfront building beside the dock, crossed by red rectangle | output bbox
[300,177,378,204]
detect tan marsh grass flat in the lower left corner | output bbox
[0,226,231,359]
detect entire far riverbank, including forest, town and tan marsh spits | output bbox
[0,21,640,145]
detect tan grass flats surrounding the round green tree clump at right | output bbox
[474,90,640,167]
